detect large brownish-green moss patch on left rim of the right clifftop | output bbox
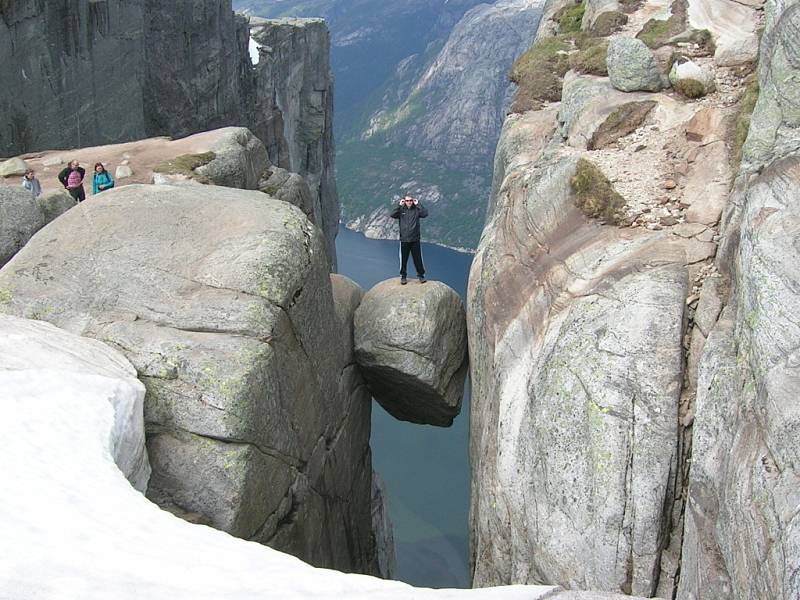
[509,37,572,112]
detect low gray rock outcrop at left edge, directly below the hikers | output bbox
[0,185,75,267]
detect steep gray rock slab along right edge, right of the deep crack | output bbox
[679,1,800,600]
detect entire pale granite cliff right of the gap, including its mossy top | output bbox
[468,0,800,600]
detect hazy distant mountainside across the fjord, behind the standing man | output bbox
[235,0,542,249]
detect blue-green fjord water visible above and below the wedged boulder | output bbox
[336,224,472,587]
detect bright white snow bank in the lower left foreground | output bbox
[0,316,576,600]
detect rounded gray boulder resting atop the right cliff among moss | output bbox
[606,38,664,92]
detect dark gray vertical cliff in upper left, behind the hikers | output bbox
[0,0,339,266]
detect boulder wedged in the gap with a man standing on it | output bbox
[355,279,467,427]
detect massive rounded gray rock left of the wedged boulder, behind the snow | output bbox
[0,185,375,573]
